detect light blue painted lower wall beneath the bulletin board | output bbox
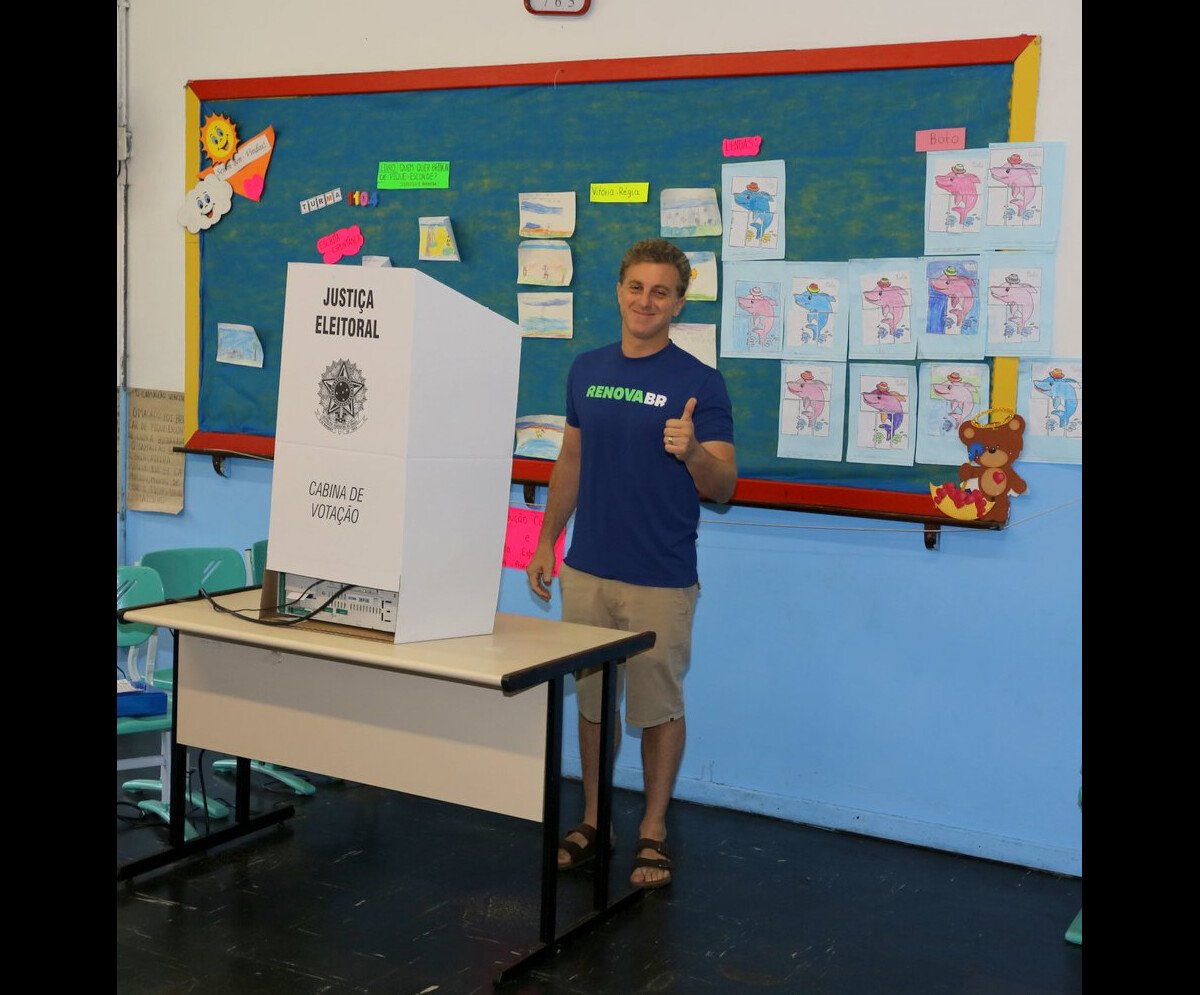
[125,456,1082,875]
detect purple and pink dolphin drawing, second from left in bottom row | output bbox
[846,362,919,466]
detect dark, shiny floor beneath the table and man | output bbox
[116,745,1084,995]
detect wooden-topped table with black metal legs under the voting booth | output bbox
[116,587,655,984]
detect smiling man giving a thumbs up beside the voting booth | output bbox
[528,239,738,888]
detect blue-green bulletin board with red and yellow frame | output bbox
[177,35,1039,519]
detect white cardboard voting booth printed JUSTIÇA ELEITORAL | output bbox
[263,263,521,642]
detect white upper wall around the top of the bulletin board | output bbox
[127,0,1084,390]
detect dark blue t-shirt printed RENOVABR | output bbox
[565,342,733,587]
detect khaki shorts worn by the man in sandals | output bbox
[558,563,700,729]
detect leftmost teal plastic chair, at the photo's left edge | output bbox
[116,567,197,839]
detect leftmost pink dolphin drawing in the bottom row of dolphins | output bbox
[776,362,846,460]
